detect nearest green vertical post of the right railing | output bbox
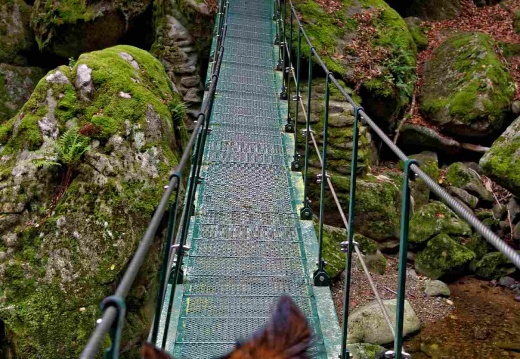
[394,160,419,359]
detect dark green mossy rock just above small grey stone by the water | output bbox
[415,234,475,279]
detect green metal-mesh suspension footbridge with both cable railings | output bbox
[81,0,520,359]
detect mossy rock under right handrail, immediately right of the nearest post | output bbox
[409,202,471,243]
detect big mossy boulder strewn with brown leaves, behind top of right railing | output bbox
[293,0,417,126]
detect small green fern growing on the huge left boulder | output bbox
[54,127,90,167]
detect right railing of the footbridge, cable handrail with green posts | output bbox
[274,0,520,359]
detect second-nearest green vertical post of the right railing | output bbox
[340,107,363,359]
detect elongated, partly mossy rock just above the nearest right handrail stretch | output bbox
[446,162,493,203]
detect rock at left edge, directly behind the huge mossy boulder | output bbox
[0,64,45,124]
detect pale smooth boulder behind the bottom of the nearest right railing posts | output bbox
[347,299,421,345]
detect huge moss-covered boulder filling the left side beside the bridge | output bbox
[0,46,185,359]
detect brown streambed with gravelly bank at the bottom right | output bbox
[332,256,520,359]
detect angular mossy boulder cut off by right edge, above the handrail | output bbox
[480,118,520,197]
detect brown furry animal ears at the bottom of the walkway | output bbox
[141,296,311,359]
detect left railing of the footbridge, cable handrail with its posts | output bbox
[80,0,229,359]
